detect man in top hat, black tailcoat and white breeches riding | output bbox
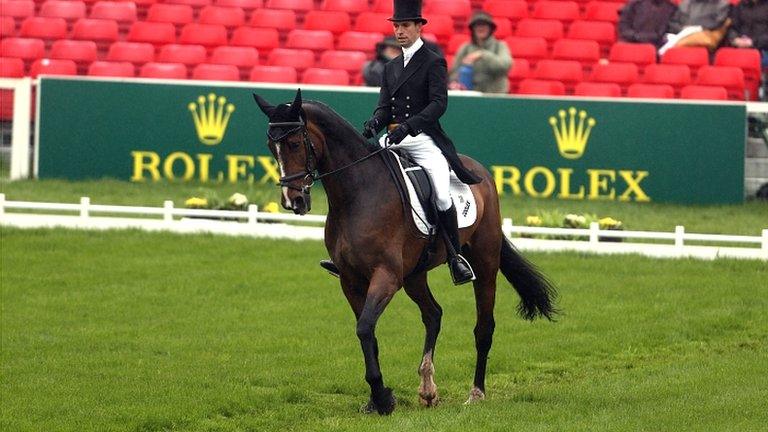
[321,0,482,285]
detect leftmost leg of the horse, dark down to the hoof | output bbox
[357,269,400,415]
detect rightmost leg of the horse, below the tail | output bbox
[467,228,501,403]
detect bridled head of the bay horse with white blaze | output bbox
[253,89,318,215]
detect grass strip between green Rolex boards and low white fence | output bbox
[0,179,768,236]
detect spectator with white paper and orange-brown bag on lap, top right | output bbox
[659,0,731,54]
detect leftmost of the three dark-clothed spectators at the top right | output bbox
[619,0,677,48]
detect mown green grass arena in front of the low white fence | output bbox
[0,228,768,432]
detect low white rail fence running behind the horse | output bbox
[0,194,768,261]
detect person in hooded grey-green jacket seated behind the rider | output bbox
[449,11,512,93]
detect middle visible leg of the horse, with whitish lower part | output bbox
[405,273,443,407]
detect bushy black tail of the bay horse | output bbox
[500,236,558,321]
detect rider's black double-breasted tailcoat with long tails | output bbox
[373,45,482,184]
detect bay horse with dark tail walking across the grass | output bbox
[254,90,556,415]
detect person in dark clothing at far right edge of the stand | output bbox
[728,0,768,67]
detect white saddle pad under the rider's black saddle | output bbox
[390,150,477,235]
